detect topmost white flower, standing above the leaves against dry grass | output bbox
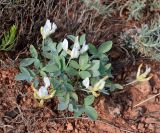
[41,19,57,39]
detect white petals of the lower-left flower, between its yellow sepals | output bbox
[38,77,50,97]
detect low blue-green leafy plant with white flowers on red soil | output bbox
[16,20,122,120]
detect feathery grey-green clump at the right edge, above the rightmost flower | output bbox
[122,21,160,60]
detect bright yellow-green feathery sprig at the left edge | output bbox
[0,25,17,51]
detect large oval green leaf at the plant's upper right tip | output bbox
[98,41,112,53]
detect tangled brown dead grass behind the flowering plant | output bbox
[0,0,124,50]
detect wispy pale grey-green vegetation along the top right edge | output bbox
[83,0,160,20]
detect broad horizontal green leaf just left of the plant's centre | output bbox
[42,64,59,72]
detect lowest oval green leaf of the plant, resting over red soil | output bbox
[85,106,98,120]
